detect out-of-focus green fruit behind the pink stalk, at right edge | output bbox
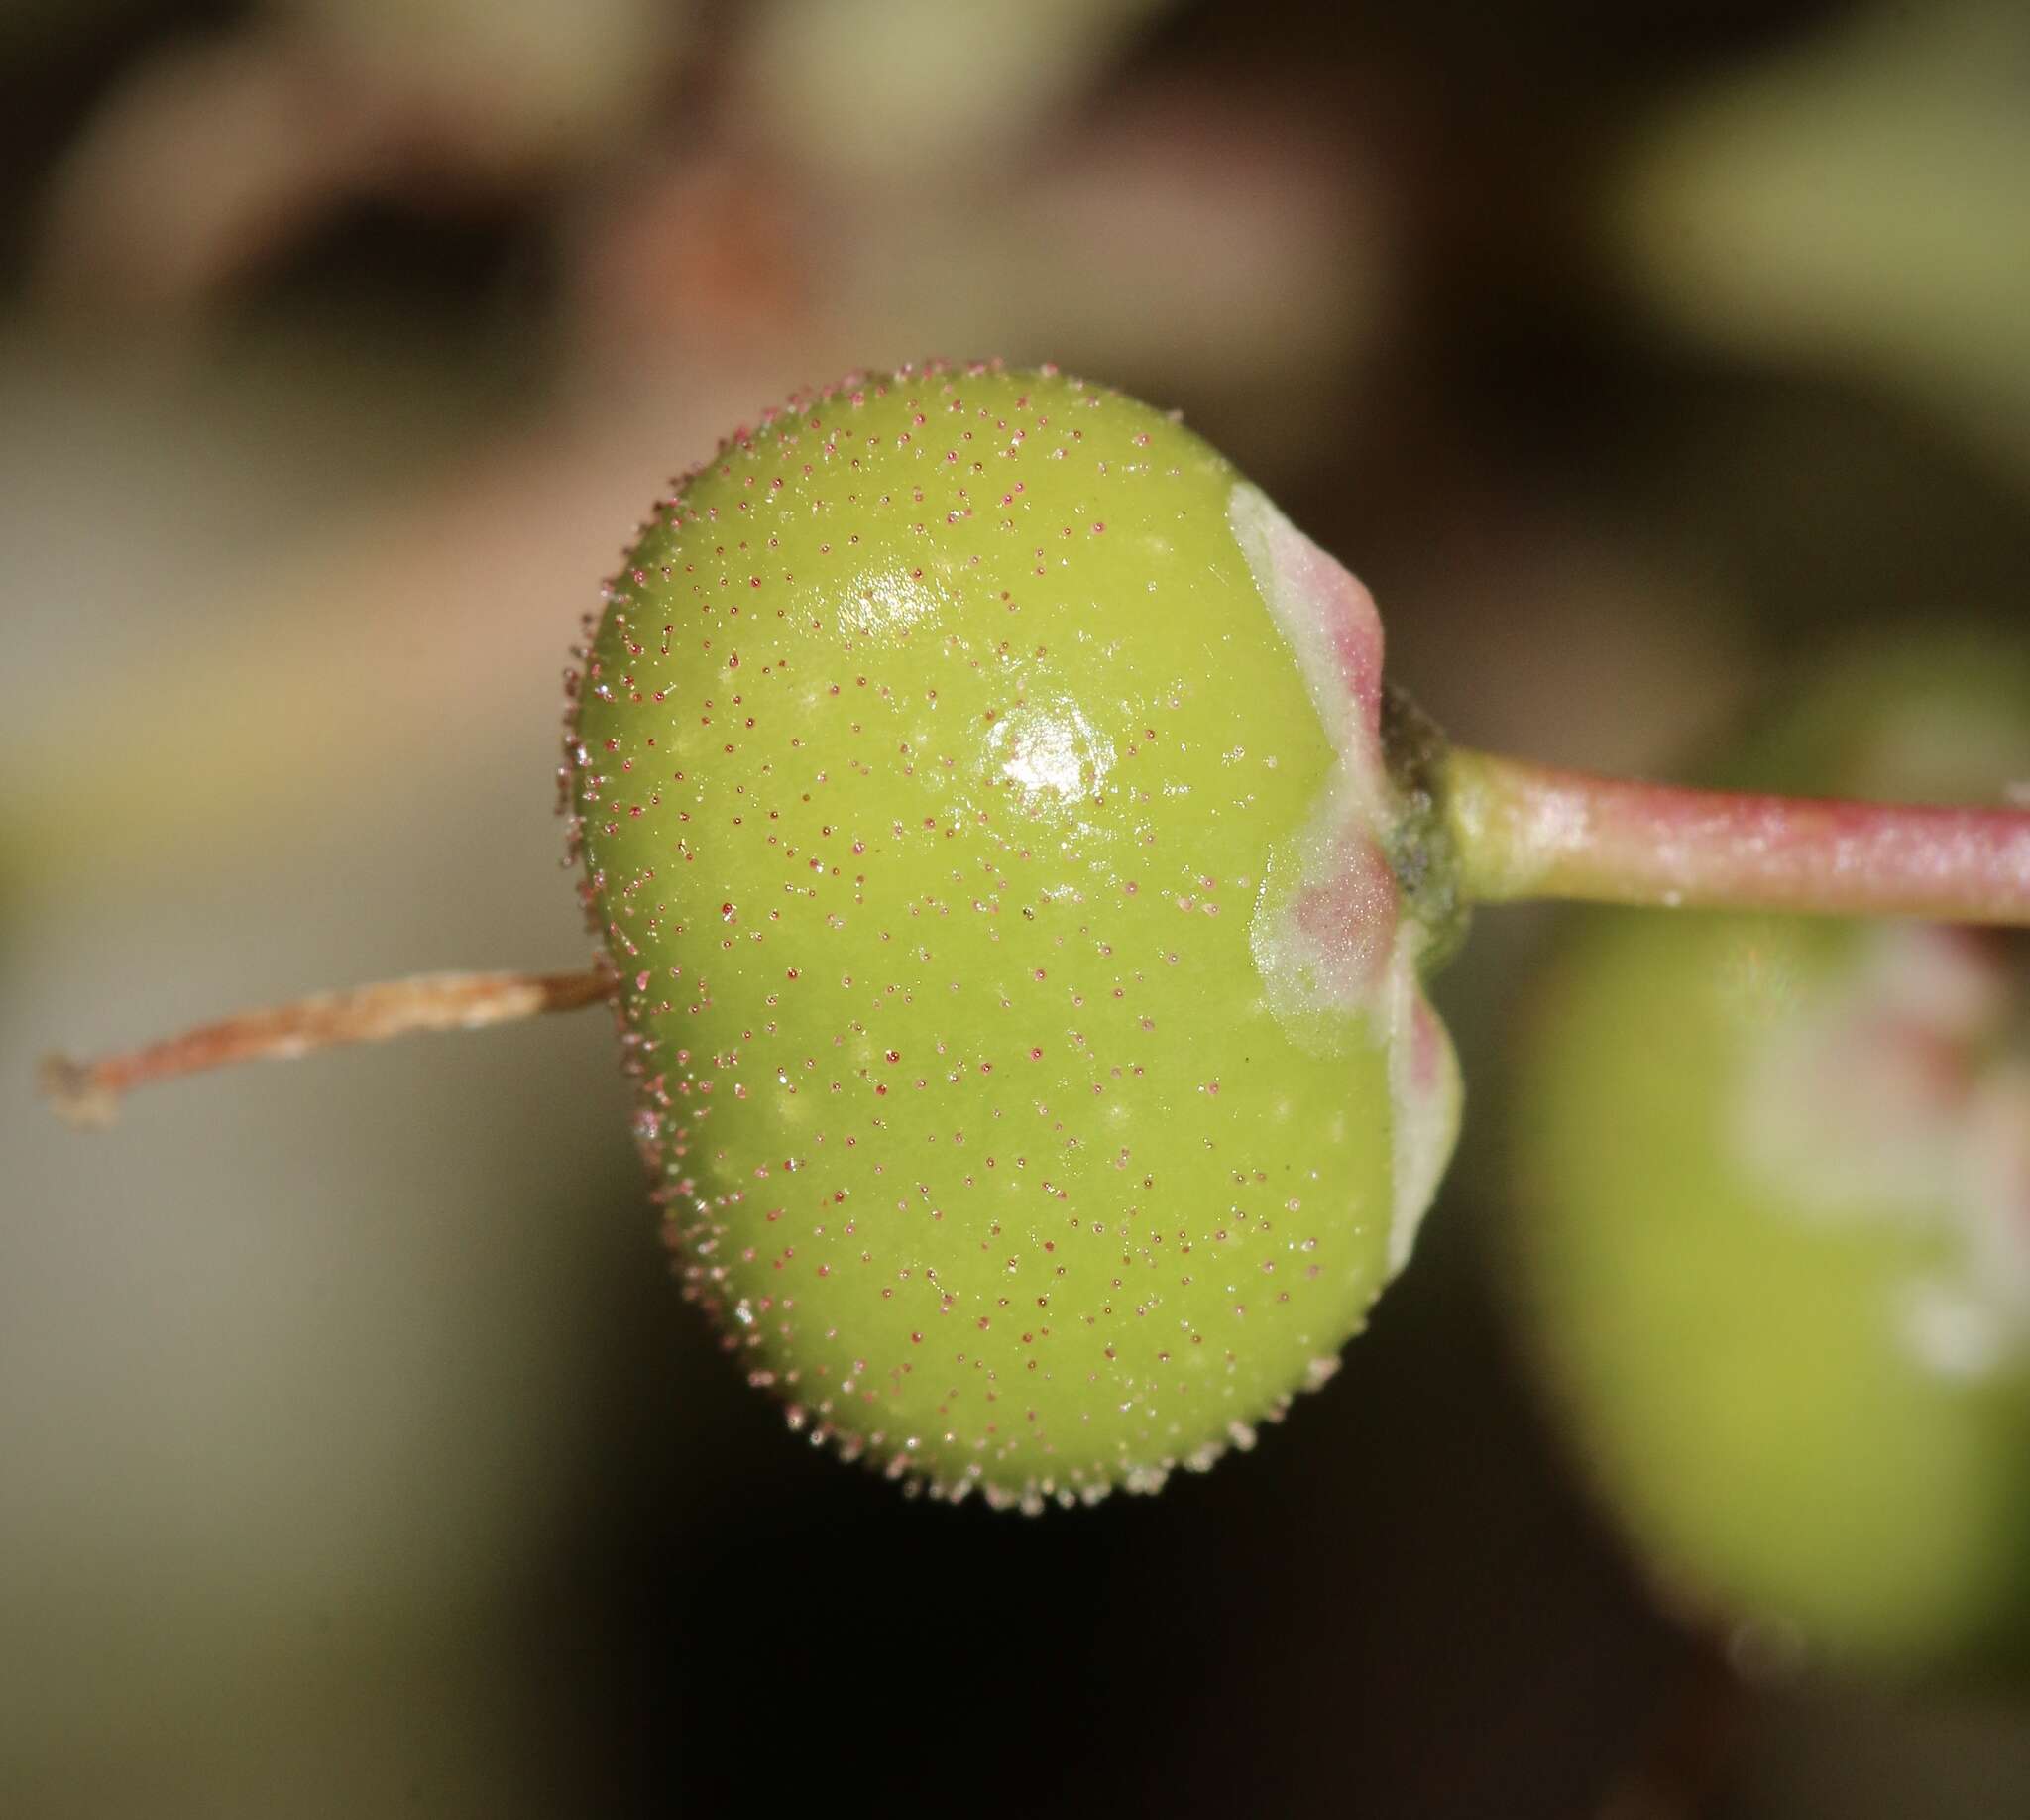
[1515,635,2030,1673]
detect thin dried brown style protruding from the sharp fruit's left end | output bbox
[39,967,618,1125]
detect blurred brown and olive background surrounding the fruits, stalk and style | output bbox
[0,0,2030,1820]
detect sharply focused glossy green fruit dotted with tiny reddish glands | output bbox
[566,355,1460,1509]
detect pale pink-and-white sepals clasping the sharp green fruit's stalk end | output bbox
[1226,484,1462,1272]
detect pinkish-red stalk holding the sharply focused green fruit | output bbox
[1445,747,2030,926]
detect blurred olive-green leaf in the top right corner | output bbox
[1618,0,2030,491]
